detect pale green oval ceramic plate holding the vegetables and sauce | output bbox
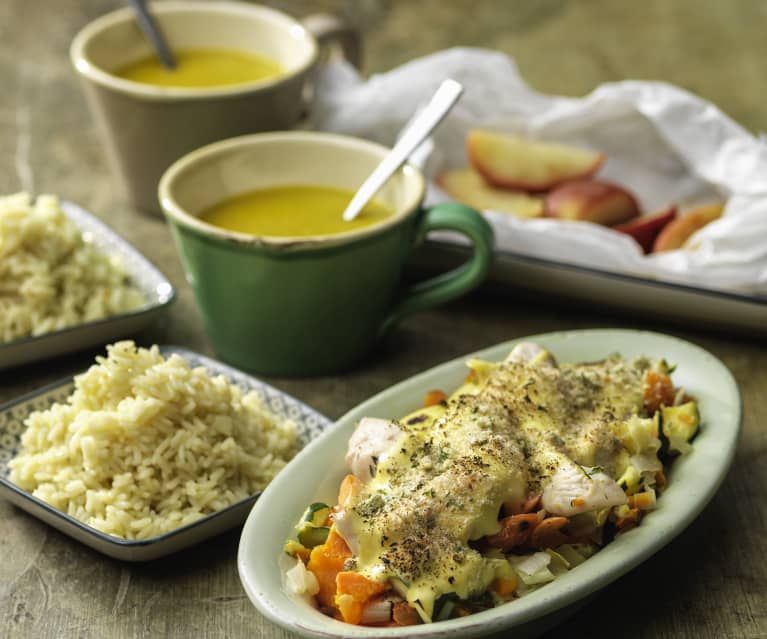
[237,329,741,639]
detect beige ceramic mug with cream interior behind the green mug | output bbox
[70,0,359,214]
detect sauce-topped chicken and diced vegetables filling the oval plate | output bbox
[285,343,699,626]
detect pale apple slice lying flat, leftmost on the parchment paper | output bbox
[436,168,543,217]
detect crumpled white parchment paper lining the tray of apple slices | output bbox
[312,48,767,295]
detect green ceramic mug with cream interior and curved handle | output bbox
[159,132,493,376]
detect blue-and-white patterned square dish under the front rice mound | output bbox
[0,345,331,548]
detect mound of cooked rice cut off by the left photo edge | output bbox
[0,193,144,341]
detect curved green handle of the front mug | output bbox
[379,202,495,337]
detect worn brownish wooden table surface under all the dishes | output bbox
[0,0,767,639]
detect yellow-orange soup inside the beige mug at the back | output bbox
[115,49,283,88]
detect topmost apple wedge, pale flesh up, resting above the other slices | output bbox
[466,129,605,193]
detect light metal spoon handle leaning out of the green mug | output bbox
[344,79,463,222]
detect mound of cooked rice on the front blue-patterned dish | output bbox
[10,341,296,539]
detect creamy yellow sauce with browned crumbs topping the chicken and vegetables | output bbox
[349,360,642,618]
